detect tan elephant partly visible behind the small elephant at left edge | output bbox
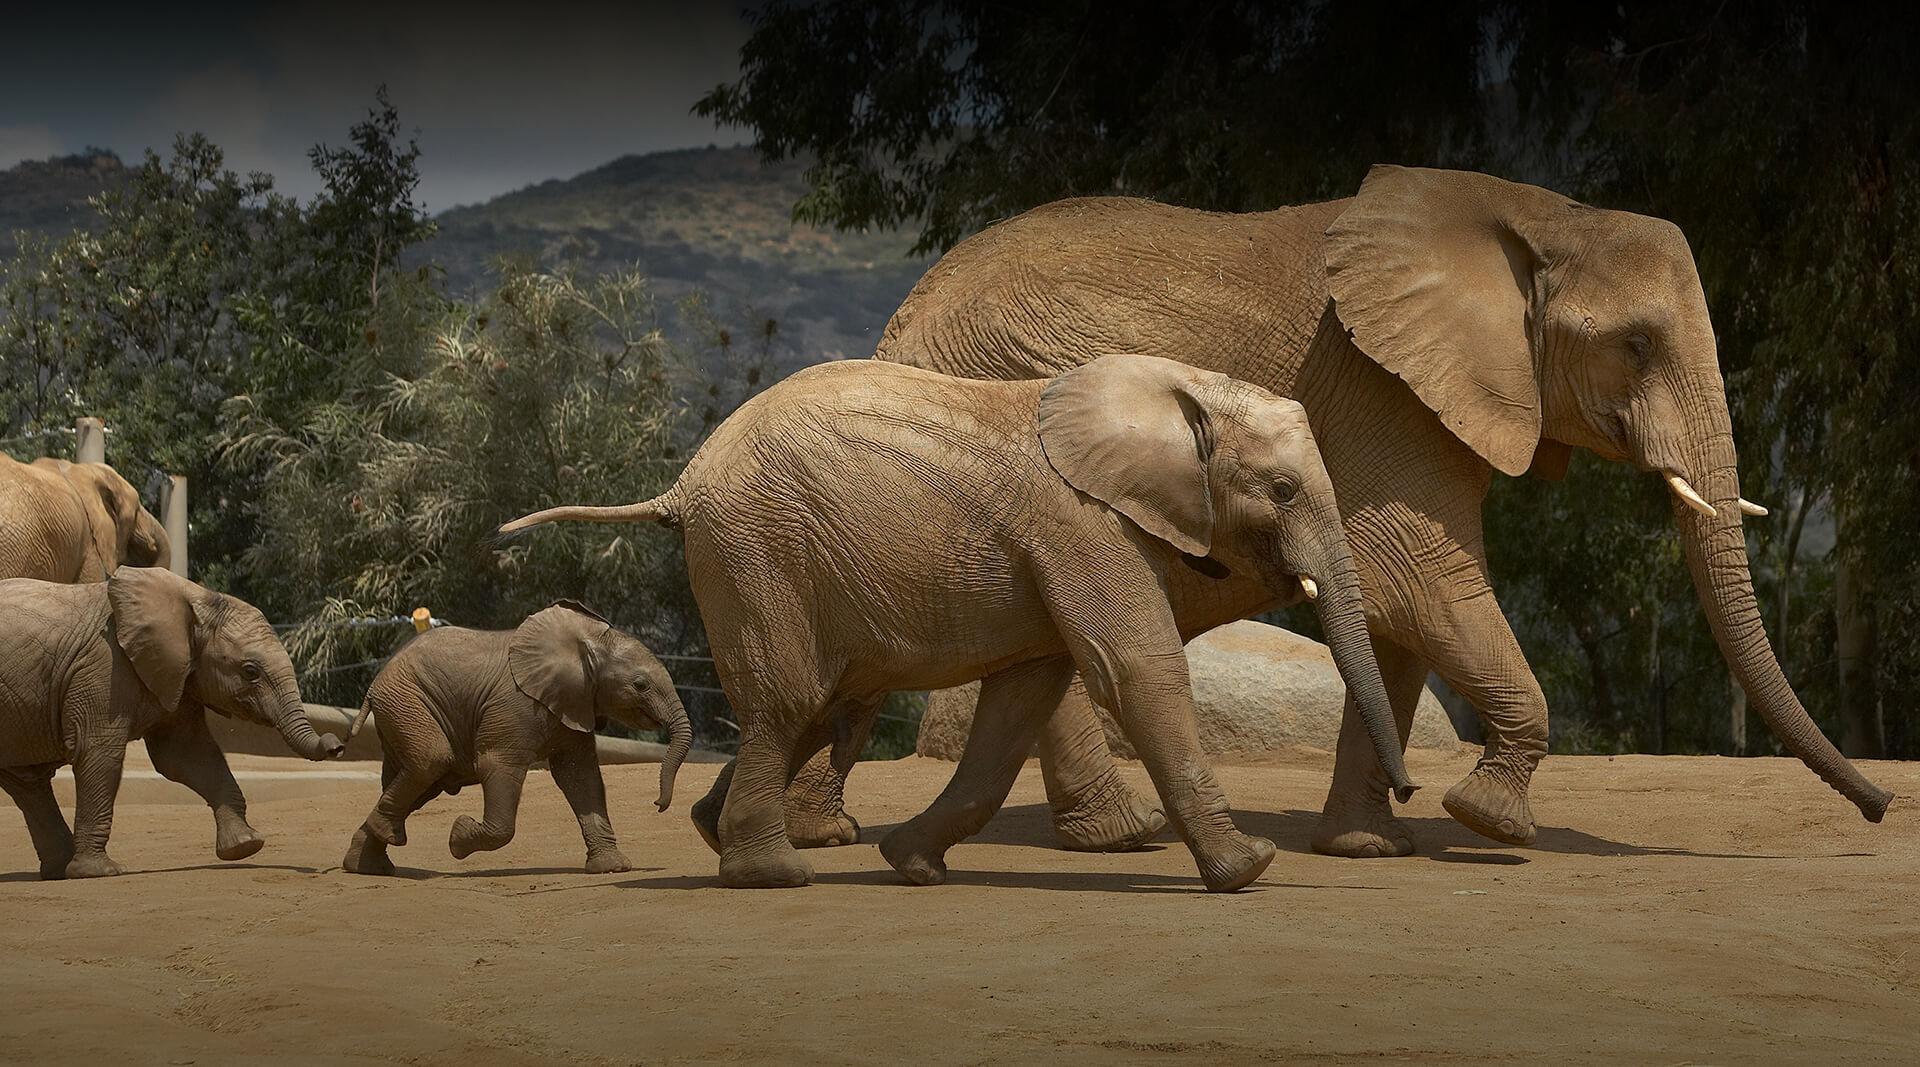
[0,455,173,581]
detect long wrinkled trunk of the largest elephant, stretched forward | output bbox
[1672,389,1893,823]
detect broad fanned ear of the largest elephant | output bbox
[1327,167,1578,474]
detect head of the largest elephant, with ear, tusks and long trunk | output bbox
[1327,167,1893,821]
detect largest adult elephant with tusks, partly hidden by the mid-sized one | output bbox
[803,167,1891,856]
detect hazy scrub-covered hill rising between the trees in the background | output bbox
[422,148,931,370]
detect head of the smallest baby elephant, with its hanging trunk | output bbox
[507,601,693,812]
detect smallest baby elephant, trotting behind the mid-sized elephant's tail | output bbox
[342,601,693,875]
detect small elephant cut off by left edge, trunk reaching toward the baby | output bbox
[0,566,342,879]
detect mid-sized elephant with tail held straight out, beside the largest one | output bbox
[501,355,1413,890]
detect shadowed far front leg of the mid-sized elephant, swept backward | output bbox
[879,656,1073,885]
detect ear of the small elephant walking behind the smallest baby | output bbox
[108,566,219,708]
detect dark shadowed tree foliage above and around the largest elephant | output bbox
[697,0,1920,756]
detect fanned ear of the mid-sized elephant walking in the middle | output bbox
[1041,355,1227,557]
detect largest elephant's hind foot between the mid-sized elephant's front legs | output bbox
[1044,677,1167,852]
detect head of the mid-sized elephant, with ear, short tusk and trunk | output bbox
[1039,355,1417,802]
